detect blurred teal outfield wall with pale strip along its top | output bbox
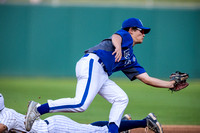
[0,0,200,78]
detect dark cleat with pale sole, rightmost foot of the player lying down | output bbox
[146,113,163,133]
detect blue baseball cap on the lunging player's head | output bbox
[122,18,151,34]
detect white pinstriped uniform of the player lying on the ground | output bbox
[0,108,108,133]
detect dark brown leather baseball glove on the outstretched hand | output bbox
[169,71,189,92]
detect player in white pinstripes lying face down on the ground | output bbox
[0,94,162,133]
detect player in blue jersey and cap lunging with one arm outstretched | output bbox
[25,18,175,133]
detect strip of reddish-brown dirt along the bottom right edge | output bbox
[131,125,200,133]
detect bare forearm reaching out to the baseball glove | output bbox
[136,73,175,88]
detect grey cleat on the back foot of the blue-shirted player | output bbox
[25,101,40,131]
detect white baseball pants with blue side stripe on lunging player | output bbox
[48,53,128,126]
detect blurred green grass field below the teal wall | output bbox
[0,78,200,125]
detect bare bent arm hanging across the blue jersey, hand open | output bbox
[112,34,122,62]
